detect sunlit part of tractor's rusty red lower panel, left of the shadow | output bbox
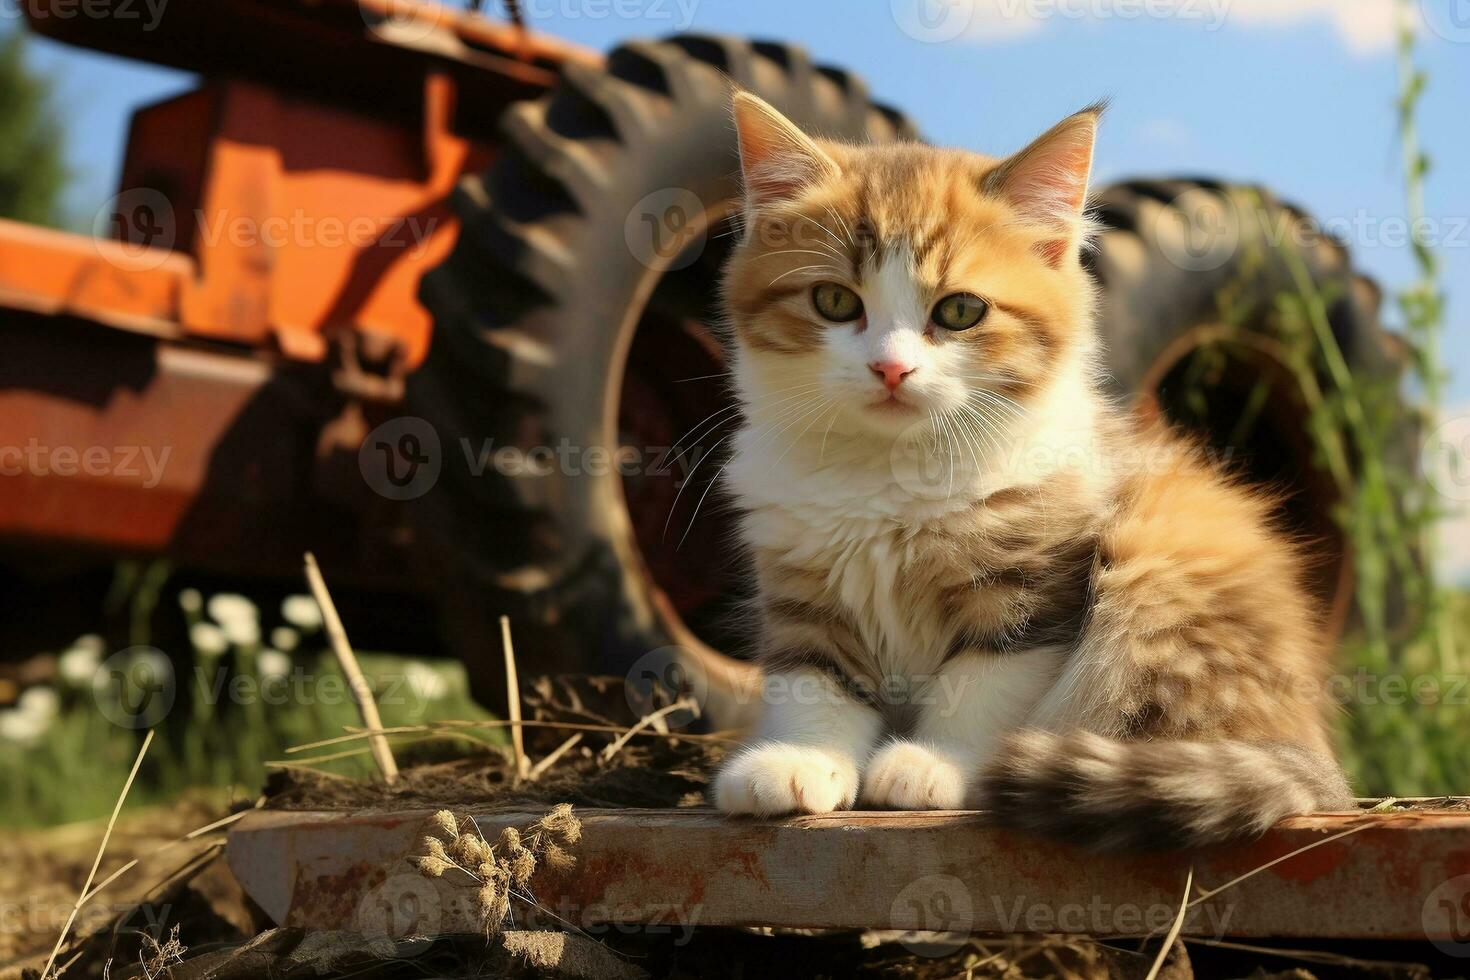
[0,320,270,551]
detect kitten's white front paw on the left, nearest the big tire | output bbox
[714,743,857,817]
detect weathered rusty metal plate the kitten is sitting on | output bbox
[229,810,1470,954]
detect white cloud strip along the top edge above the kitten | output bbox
[892,0,1395,54]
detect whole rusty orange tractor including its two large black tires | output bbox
[0,0,1404,727]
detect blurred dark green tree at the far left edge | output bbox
[0,29,68,225]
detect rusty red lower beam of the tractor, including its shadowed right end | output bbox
[0,320,422,591]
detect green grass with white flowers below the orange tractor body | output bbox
[0,594,503,827]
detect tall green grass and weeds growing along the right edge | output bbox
[1340,0,1470,795]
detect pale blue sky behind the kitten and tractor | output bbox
[14,0,1470,570]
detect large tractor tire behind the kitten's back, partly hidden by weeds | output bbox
[1089,179,1416,638]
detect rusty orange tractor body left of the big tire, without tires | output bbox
[0,0,585,585]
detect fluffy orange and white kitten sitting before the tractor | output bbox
[714,93,1351,848]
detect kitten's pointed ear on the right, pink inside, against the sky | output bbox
[985,103,1104,266]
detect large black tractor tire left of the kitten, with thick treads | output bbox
[409,37,914,724]
